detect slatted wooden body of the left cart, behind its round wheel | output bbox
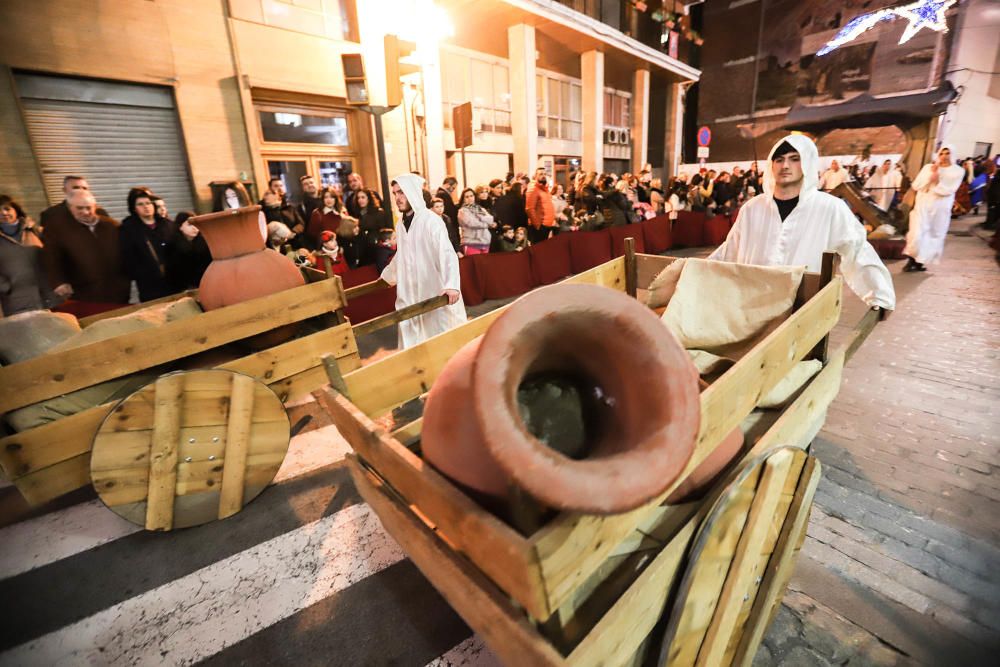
[0,279,361,505]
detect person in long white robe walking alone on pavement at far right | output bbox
[903,144,965,271]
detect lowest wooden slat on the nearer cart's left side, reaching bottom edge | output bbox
[347,454,565,667]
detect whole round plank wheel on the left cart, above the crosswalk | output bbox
[90,370,290,530]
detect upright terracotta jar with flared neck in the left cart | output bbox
[189,206,305,349]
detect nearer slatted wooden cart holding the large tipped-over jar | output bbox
[315,254,877,666]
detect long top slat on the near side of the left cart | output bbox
[0,280,344,412]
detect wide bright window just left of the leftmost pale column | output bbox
[441,52,511,134]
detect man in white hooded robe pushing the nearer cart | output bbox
[708,134,896,317]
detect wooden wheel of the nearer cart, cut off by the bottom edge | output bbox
[659,447,820,667]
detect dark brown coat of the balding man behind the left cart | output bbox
[42,216,129,303]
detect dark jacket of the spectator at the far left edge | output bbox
[0,220,59,317]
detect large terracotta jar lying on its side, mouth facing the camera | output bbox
[422,285,701,514]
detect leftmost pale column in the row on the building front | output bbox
[507,23,538,174]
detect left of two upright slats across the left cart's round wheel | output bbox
[146,374,184,530]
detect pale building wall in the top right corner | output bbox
[938,0,1000,157]
